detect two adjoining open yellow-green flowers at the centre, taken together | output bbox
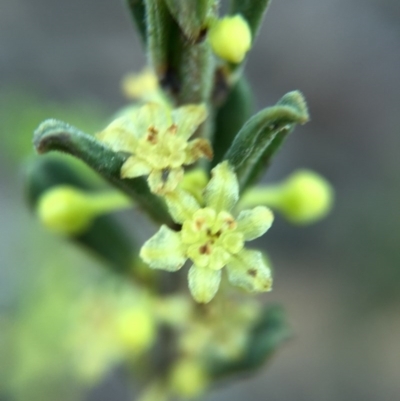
[97,103,273,303]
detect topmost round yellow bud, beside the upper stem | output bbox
[208,14,251,63]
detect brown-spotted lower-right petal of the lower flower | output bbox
[227,249,272,292]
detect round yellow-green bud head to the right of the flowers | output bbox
[276,170,334,224]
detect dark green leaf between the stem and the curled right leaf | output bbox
[212,76,253,166]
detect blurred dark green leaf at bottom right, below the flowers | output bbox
[208,306,291,379]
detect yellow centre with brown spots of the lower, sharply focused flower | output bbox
[182,208,244,269]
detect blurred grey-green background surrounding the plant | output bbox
[0,0,400,401]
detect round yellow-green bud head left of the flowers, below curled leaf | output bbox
[37,186,94,235]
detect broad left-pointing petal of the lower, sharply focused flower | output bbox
[140,225,186,271]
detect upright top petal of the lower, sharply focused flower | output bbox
[204,161,239,212]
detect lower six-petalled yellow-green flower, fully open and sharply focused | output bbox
[140,162,273,303]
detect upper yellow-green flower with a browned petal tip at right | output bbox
[97,103,213,194]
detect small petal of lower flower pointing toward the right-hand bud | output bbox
[236,206,274,241]
